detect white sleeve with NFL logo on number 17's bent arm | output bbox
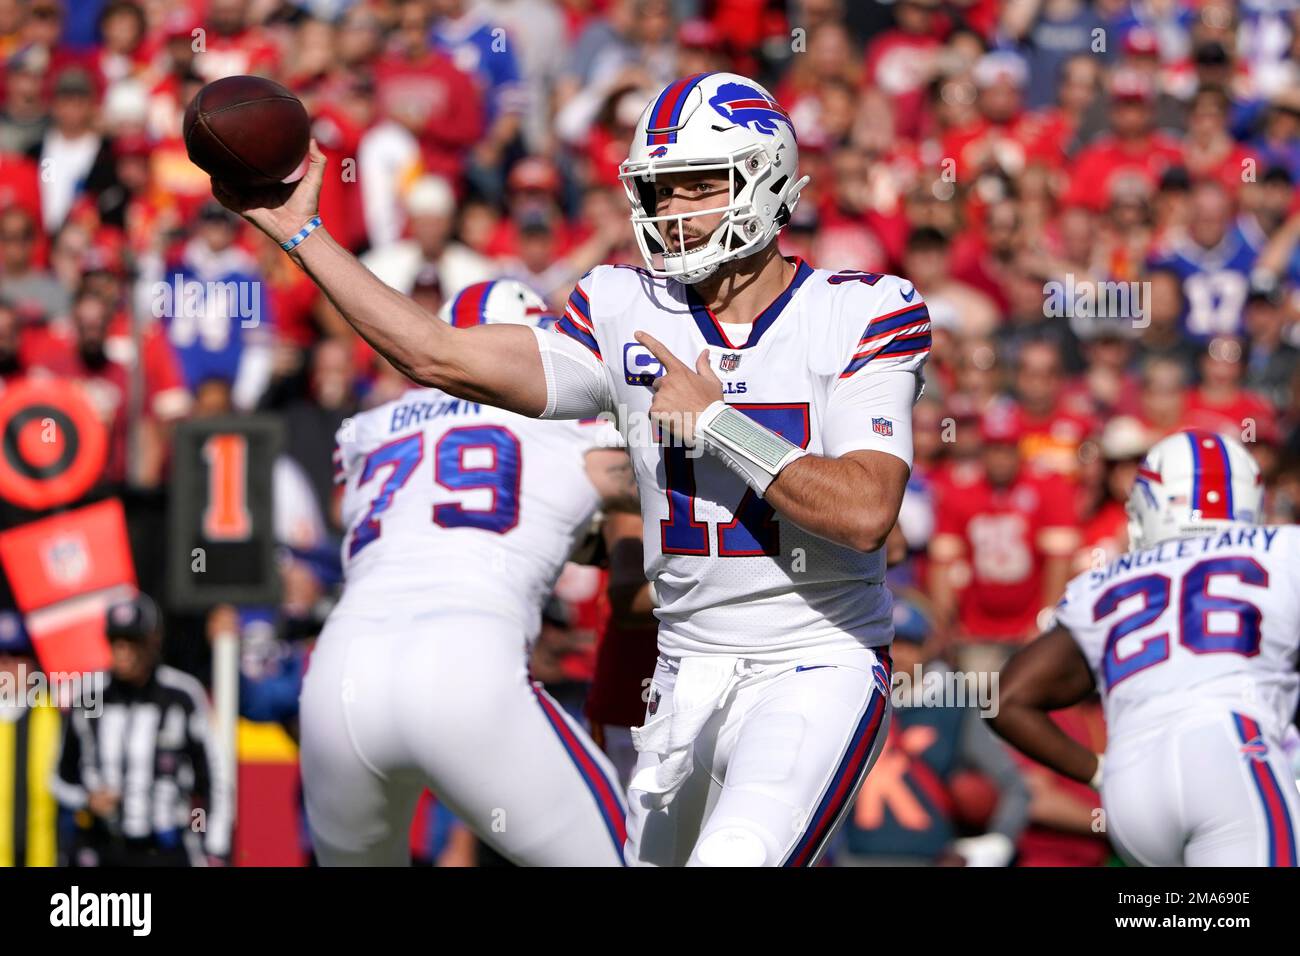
[822,369,917,468]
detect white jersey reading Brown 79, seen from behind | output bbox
[334,389,618,640]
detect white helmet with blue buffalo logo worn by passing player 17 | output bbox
[619,73,809,285]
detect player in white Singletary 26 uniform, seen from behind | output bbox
[993,432,1300,866]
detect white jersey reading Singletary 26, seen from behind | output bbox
[1057,524,1300,736]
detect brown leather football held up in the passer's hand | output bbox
[182,77,311,186]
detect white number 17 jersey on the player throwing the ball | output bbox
[555,261,930,657]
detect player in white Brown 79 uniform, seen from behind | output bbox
[300,280,636,866]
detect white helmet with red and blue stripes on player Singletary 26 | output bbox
[1126,431,1264,551]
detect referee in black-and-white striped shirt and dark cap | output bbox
[55,594,233,866]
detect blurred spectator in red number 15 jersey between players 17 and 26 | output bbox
[930,402,1079,670]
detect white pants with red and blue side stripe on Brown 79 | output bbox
[302,611,625,866]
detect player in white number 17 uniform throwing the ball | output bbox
[223,73,930,866]
